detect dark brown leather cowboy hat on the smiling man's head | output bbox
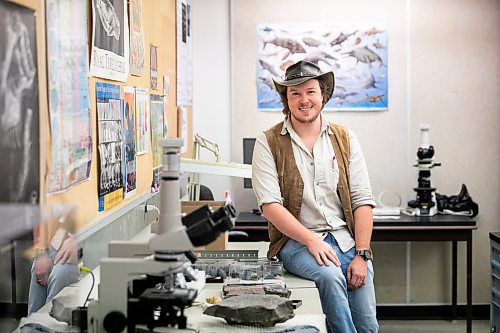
[273,60,335,104]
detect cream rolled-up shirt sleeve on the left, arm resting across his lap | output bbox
[252,133,283,207]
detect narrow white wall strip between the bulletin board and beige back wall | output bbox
[191,0,231,200]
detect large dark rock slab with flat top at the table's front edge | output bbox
[203,295,294,327]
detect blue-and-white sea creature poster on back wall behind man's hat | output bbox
[257,23,388,111]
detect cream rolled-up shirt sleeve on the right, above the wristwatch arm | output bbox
[349,131,375,210]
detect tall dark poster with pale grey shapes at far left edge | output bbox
[0,1,40,203]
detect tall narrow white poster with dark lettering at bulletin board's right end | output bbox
[176,0,193,106]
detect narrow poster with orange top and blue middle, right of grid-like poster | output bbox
[123,87,137,199]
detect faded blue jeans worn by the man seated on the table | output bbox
[278,233,379,333]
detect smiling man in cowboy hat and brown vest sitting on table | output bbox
[252,61,379,333]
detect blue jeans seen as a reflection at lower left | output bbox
[28,248,78,316]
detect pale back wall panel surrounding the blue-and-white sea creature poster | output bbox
[231,0,411,213]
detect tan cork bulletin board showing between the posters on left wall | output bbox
[2,0,192,230]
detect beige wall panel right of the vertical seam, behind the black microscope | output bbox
[410,0,500,303]
